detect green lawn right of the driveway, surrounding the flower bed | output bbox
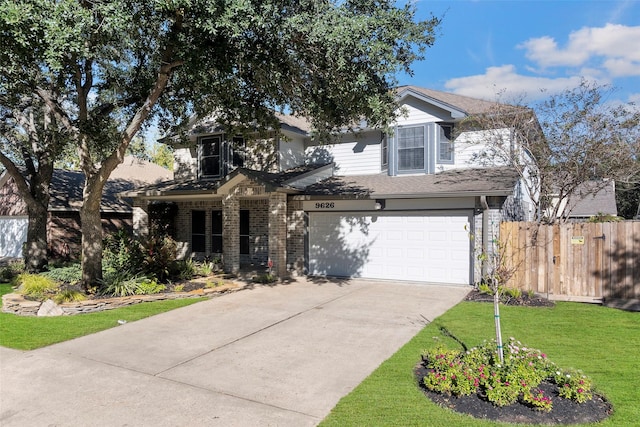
[320,302,640,427]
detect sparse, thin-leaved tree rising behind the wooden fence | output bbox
[464,80,640,222]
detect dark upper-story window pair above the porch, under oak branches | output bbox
[198,134,246,179]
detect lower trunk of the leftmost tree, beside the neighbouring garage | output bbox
[22,201,48,273]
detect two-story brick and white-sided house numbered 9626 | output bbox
[126,86,528,284]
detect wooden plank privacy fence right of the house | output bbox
[497,221,640,302]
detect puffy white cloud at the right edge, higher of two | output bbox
[517,24,640,75]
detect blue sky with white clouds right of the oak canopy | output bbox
[400,0,640,105]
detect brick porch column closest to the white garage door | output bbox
[269,193,287,277]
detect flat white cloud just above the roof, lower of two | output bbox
[445,65,582,102]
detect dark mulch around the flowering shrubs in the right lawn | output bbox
[414,362,613,425]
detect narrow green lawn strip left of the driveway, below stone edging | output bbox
[0,284,205,350]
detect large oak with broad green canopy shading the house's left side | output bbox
[0,0,439,284]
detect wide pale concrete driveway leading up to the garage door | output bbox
[0,279,469,427]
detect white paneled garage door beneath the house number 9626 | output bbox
[309,211,472,284]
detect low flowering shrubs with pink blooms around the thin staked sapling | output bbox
[422,338,592,411]
